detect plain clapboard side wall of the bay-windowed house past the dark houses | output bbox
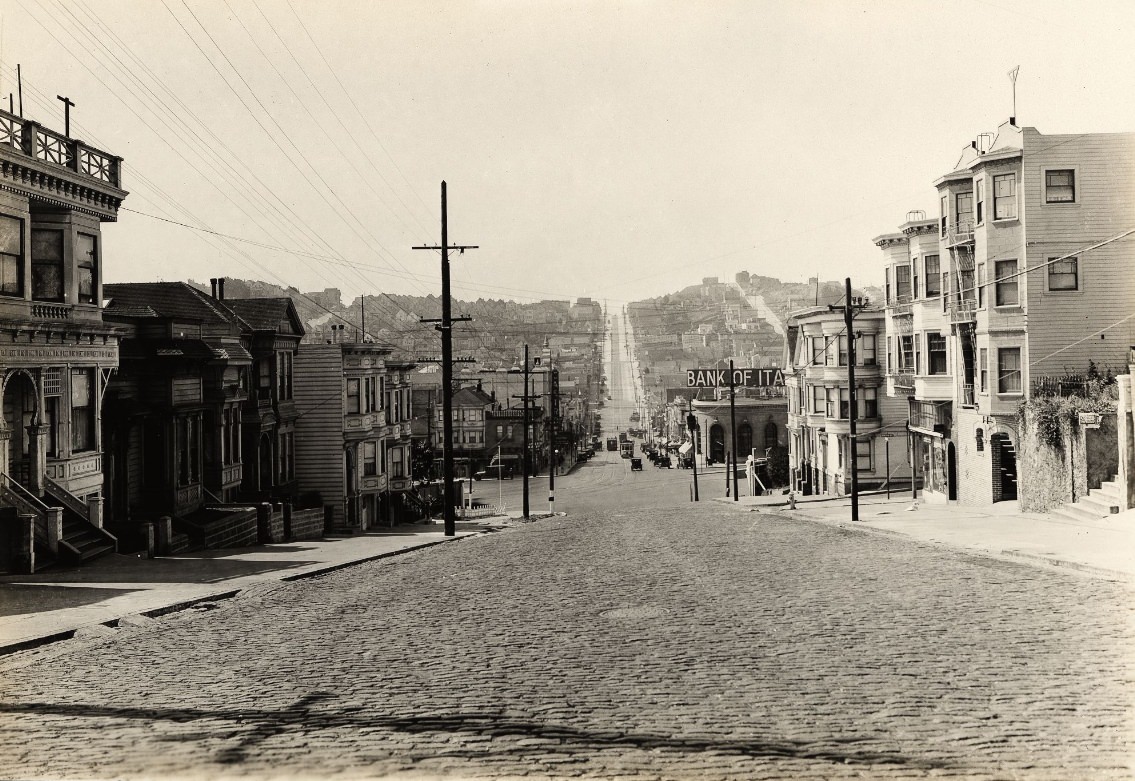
[293,344,346,508]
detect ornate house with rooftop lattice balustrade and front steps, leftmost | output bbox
[0,105,127,571]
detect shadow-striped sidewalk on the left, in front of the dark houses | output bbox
[0,513,526,655]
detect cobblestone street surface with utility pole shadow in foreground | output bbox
[0,485,1135,780]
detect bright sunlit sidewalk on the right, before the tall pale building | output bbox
[713,493,1135,583]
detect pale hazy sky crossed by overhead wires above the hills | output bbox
[0,0,1135,306]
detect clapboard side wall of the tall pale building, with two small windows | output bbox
[1023,128,1135,383]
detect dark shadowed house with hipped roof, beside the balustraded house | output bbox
[103,283,257,547]
